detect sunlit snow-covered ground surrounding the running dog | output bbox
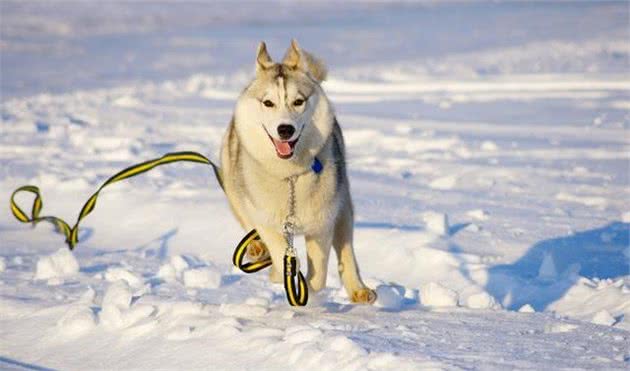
[0,1,630,370]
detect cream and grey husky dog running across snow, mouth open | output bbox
[221,40,376,303]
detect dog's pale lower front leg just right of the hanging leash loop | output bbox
[306,233,332,291]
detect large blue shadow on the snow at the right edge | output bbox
[486,222,630,311]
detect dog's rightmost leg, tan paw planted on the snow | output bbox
[333,205,376,304]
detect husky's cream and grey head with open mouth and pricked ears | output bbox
[235,40,334,166]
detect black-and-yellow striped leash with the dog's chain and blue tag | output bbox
[10,151,322,306]
